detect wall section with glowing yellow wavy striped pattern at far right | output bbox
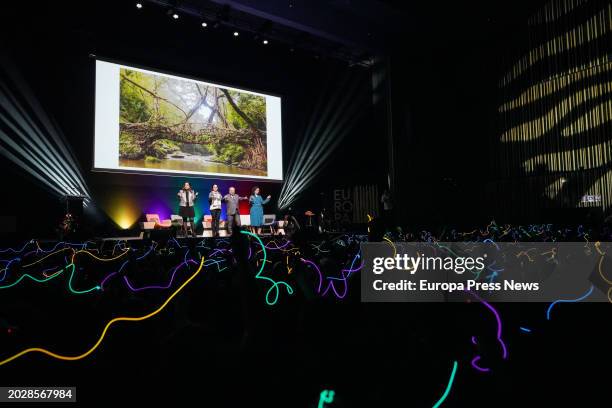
[489,0,612,214]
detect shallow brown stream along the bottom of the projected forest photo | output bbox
[119,154,267,176]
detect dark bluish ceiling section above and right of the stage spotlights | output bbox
[144,0,546,65]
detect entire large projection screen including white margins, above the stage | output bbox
[93,59,283,181]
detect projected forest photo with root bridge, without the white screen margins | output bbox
[119,68,267,176]
